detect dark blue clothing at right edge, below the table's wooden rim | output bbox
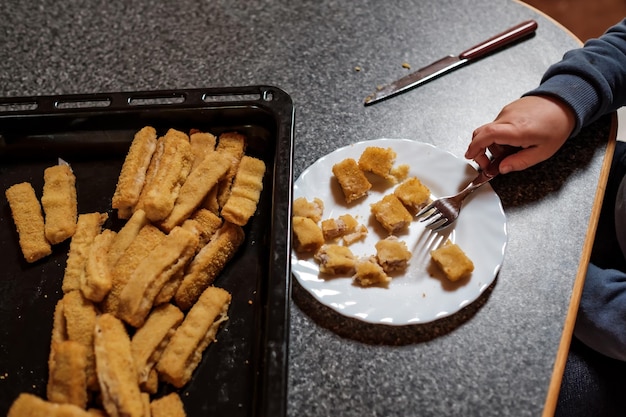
[574,264,626,361]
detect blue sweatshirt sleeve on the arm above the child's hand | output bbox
[525,19,626,136]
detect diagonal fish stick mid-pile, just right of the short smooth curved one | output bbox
[100,224,165,317]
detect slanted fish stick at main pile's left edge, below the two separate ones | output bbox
[62,213,109,292]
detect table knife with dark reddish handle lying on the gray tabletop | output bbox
[365,20,537,106]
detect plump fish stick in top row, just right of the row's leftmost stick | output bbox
[143,129,193,222]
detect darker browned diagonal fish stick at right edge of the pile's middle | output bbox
[175,222,245,310]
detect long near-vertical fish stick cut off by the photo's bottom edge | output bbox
[94,313,144,417]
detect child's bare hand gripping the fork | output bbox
[465,96,576,174]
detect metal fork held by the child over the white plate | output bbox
[416,146,519,232]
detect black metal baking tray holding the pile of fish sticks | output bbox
[0,86,294,417]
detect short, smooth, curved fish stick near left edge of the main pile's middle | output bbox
[80,229,116,303]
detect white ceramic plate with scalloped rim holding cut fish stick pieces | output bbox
[292,139,507,326]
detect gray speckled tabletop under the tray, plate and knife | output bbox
[0,0,610,417]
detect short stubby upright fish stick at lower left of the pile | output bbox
[46,340,88,408]
